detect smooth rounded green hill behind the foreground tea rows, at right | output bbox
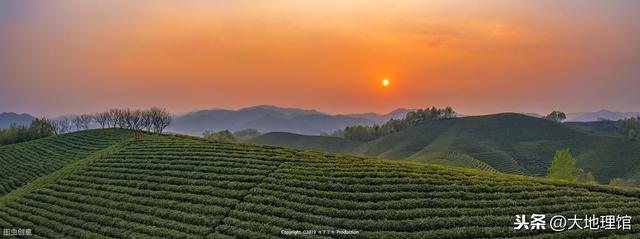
[252,113,640,182]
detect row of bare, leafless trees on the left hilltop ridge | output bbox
[52,107,172,134]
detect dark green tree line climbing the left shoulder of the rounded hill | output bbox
[344,107,456,142]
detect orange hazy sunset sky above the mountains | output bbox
[0,0,640,116]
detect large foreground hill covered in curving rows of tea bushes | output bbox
[0,131,640,238]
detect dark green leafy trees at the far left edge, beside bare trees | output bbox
[0,118,54,145]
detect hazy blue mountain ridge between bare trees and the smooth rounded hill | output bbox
[169,105,410,135]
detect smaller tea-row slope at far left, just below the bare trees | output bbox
[0,129,132,196]
